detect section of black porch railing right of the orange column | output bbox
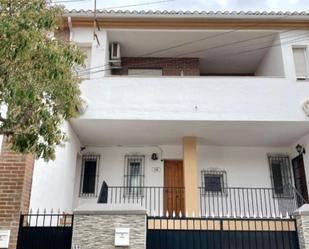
[199,185,305,218]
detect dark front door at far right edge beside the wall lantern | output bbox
[292,155,309,204]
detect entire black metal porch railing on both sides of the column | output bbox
[98,183,305,218]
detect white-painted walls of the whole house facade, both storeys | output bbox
[30,21,309,212]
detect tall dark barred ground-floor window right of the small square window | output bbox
[268,155,292,198]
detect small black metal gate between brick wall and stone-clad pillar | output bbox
[17,213,73,249]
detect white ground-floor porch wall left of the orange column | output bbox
[74,146,182,207]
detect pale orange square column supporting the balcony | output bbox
[183,137,199,216]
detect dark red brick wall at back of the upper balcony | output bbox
[113,57,200,76]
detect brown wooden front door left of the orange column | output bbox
[164,160,185,216]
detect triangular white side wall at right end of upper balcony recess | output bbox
[255,35,285,77]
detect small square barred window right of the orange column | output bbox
[202,170,226,194]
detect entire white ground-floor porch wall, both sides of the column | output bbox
[74,145,290,208]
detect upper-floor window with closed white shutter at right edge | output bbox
[293,47,308,80]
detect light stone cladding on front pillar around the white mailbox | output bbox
[72,214,146,249]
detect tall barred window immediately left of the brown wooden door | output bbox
[124,155,145,196]
